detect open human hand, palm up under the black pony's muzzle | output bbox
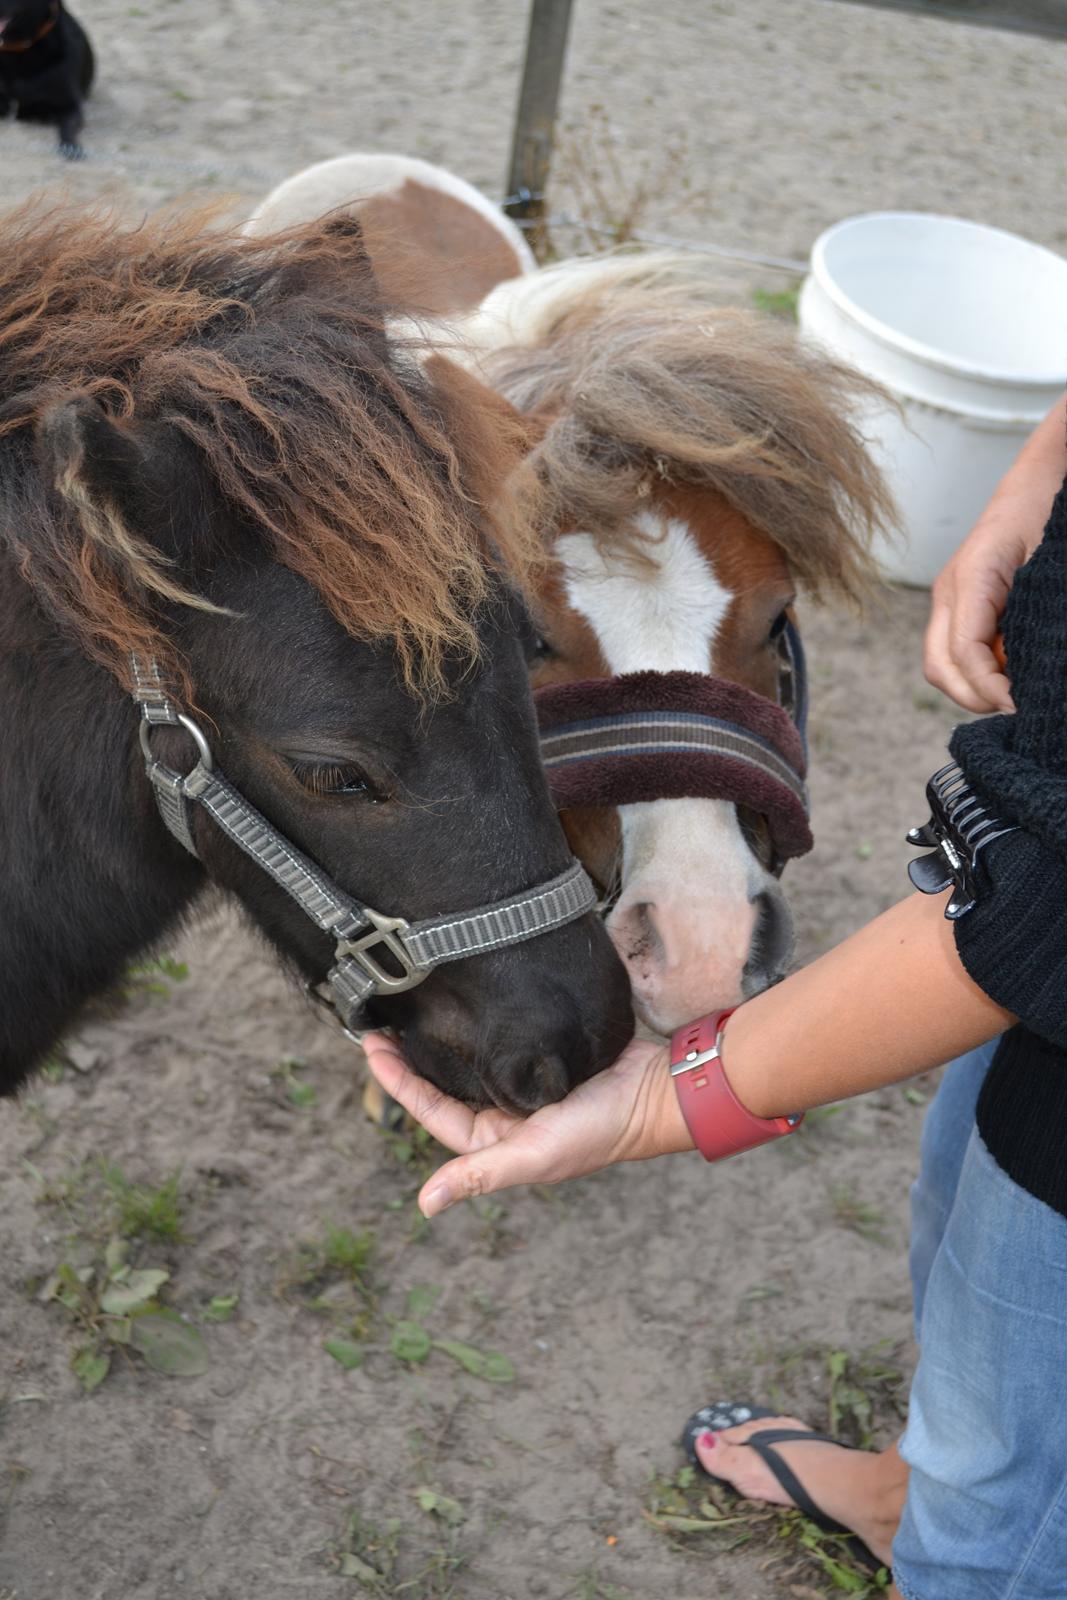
[363,1034,693,1216]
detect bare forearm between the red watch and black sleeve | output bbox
[723,894,1014,1117]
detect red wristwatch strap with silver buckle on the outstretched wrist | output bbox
[670,1006,805,1162]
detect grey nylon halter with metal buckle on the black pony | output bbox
[131,656,597,1030]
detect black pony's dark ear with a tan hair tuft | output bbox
[37,394,223,610]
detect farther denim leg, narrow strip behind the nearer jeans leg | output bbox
[909,1038,1000,1346]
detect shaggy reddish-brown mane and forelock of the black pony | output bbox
[0,203,536,691]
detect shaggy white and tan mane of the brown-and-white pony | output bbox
[454,253,896,600]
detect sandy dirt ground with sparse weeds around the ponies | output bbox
[0,0,1067,1600]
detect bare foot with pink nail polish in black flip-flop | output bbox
[696,1416,907,1566]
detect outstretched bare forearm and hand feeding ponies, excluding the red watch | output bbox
[365,894,1013,1216]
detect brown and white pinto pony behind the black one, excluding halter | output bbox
[251,157,893,1032]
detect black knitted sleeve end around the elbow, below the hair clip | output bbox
[955,829,1067,1050]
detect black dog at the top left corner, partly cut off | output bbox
[0,0,94,162]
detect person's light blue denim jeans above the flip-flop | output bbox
[893,1042,1067,1600]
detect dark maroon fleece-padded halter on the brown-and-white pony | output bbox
[534,624,813,861]
